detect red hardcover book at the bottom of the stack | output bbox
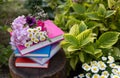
[15,57,49,68]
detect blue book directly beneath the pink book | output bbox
[14,45,51,57]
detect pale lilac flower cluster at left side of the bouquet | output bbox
[10,15,29,49]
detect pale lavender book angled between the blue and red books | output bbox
[30,43,61,65]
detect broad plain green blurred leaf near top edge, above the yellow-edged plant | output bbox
[72,3,86,14]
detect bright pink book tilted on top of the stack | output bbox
[17,20,64,55]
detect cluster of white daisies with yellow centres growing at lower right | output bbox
[74,56,120,78]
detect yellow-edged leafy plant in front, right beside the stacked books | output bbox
[61,21,119,69]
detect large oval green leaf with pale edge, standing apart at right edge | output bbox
[97,32,119,48]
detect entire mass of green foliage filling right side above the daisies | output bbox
[51,0,120,74]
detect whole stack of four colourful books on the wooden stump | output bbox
[14,20,64,68]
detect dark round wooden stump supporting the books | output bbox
[9,50,66,78]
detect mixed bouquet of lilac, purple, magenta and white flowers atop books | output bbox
[10,15,47,49]
